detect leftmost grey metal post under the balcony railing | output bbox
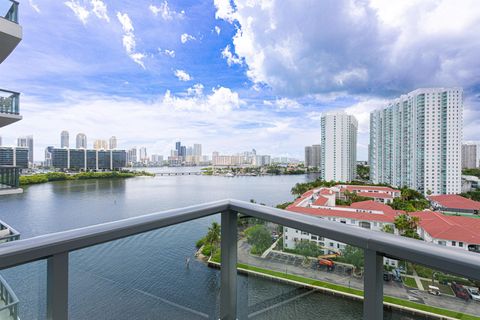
[47,252,68,320]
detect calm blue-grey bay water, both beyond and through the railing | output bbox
[0,169,420,320]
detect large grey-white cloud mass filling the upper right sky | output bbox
[214,0,480,96]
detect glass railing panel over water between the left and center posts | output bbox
[69,216,220,320]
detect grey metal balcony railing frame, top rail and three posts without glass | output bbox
[0,200,480,320]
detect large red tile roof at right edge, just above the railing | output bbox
[411,211,480,244]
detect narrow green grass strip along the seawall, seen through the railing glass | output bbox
[238,263,480,320]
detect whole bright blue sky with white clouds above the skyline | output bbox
[0,0,480,160]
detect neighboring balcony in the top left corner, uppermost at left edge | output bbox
[0,0,22,63]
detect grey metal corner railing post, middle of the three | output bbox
[220,210,237,320]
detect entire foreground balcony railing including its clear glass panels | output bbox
[0,200,480,320]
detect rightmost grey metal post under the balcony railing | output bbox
[363,249,383,320]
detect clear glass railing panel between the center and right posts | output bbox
[238,217,364,319]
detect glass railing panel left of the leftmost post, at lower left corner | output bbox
[0,260,47,320]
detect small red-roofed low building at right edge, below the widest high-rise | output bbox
[427,194,480,215]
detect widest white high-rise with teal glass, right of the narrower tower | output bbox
[369,88,463,194]
